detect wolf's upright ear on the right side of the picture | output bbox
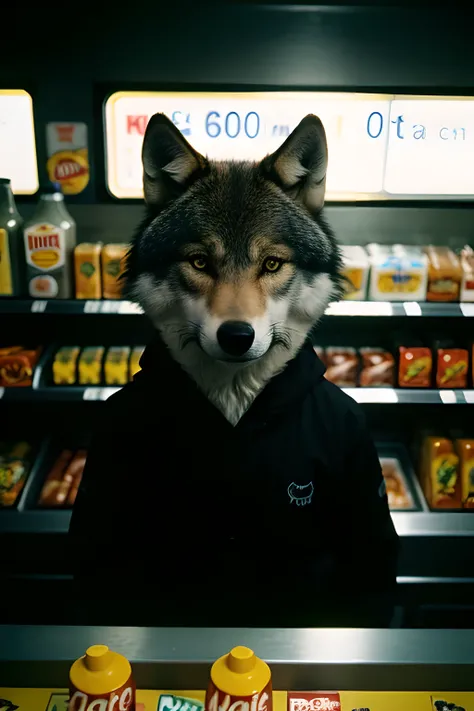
[262,114,328,213]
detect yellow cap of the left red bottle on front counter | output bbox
[69,644,132,696]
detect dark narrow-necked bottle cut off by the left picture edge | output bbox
[0,178,24,296]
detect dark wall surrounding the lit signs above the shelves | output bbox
[0,0,474,246]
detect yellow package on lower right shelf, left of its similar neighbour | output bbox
[420,437,461,509]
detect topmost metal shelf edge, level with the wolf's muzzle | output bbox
[0,298,474,318]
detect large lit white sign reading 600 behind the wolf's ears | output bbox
[106,91,474,201]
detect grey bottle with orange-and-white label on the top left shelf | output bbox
[24,183,76,299]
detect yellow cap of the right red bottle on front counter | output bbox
[211,647,271,696]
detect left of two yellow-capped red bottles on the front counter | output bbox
[68,644,136,711]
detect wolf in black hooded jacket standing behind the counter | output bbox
[71,114,397,626]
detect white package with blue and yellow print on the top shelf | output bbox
[367,244,428,301]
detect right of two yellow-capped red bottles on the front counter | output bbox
[205,647,273,711]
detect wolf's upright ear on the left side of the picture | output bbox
[142,114,208,207]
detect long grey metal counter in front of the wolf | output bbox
[0,628,474,691]
